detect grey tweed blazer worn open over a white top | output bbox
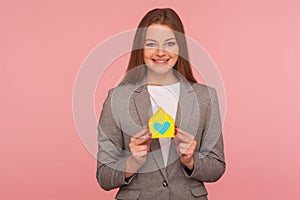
[96,79,226,200]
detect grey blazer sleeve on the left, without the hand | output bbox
[96,89,132,190]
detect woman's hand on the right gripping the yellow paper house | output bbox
[175,128,197,170]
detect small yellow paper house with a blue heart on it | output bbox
[148,108,175,138]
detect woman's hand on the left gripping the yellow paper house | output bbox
[129,128,151,165]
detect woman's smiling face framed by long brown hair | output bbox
[143,24,179,74]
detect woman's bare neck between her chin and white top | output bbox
[146,70,179,85]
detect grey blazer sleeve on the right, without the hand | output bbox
[183,88,226,182]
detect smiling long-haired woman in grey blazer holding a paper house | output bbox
[96,8,225,199]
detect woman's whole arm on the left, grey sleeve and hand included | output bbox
[96,90,151,190]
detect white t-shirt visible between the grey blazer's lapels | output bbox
[147,82,180,166]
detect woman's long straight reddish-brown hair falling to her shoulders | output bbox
[120,8,197,85]
